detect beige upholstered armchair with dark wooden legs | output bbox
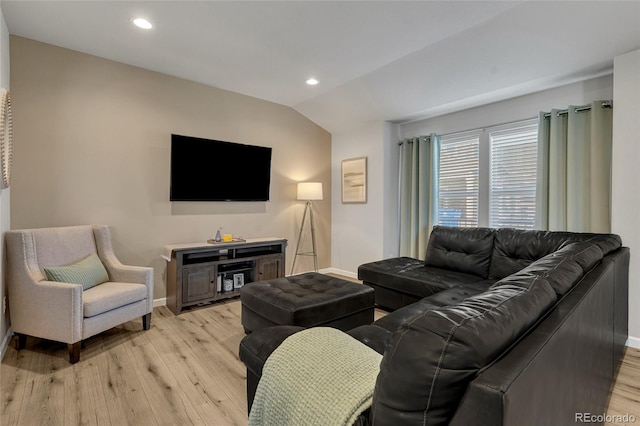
[5,225,153,363]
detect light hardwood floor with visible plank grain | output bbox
[0,300,640,426]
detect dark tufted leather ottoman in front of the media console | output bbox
[240,272,374,333]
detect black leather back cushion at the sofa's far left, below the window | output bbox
[424,226,494,278]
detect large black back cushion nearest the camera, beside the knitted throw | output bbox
[371,275,556,425]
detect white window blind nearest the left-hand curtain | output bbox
[438,133,480,227]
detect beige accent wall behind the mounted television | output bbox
[10,36,331,298]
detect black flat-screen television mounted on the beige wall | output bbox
[170,135,271,201]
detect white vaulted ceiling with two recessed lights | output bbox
[2,0,640,132]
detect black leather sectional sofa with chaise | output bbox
[240,226,629,426]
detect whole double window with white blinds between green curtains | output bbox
[438,119,538,229]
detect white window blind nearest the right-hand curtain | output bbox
[489,120,538,229]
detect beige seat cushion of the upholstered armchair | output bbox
[82,281,147,318]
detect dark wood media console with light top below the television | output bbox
[163,238,287,315]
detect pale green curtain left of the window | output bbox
[399,134,440,259]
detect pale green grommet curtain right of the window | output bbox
[537,101,613,232]
